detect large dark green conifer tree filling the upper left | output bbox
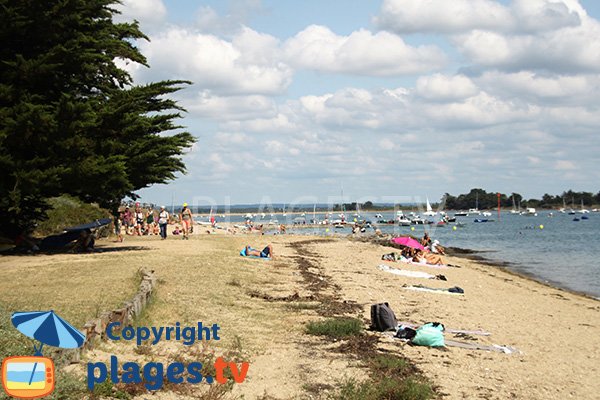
[0,0,194,233]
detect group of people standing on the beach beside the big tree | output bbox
[115,203,194,242]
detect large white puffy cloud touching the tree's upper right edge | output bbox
[134,27,292,94]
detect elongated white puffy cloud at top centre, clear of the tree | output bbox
[283,25,446,76]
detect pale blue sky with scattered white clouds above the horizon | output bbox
[116,0,600,204]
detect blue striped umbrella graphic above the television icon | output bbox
[10,311,85,355]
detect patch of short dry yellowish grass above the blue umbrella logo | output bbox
[0,252,143,329]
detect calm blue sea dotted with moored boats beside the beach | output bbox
[198,211,600,298]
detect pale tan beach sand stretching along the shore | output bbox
[0,230,600,399]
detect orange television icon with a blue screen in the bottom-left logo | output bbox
[2,356,55,399]
